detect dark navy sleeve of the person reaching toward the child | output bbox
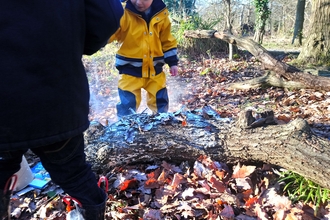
[84,0,123,55]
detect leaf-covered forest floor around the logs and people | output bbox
[12,37,330,220]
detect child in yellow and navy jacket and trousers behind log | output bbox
[109,0,178,117]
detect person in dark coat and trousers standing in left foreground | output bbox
[0,0,123,220]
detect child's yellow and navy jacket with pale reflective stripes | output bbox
[109,0,178,78]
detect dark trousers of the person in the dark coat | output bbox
[0,134,105,206]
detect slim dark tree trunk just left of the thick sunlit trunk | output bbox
[292,0,306,46]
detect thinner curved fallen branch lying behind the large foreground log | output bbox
[184,30,330,91]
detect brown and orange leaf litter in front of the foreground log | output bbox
[12,156,329,220]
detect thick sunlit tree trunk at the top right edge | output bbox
[298,0,330,65]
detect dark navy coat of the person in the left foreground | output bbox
[0,0,123,151]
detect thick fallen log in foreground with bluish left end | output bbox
[85,106,330,188]
